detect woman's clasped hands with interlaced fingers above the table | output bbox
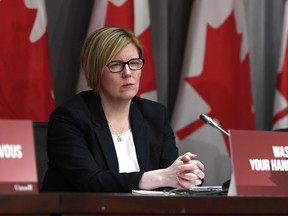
[166,152,205,189]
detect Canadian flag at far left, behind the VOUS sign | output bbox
[0,0,55,122]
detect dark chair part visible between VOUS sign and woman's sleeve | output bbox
[33,122,48,191]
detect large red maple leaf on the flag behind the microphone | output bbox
[177,12,255,152]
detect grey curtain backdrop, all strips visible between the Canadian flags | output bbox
[46,0,285,130]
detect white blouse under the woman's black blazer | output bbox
[112,129,140,173]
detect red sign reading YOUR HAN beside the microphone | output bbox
[230,130,288,195]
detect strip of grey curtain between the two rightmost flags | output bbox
[245,0,285,130]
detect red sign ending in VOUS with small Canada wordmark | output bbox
[0,119,38,193]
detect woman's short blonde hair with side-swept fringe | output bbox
[80,26,143,92]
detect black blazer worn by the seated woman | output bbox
[42,91,178,192]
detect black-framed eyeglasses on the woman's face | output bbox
[106,58,145,73]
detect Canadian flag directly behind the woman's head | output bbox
[77,0,157,101]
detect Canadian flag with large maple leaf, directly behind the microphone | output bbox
[172,0,255,185]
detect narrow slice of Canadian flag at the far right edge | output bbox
[273,1,288,130]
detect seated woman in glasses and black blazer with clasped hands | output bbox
[43,27,204,192]
